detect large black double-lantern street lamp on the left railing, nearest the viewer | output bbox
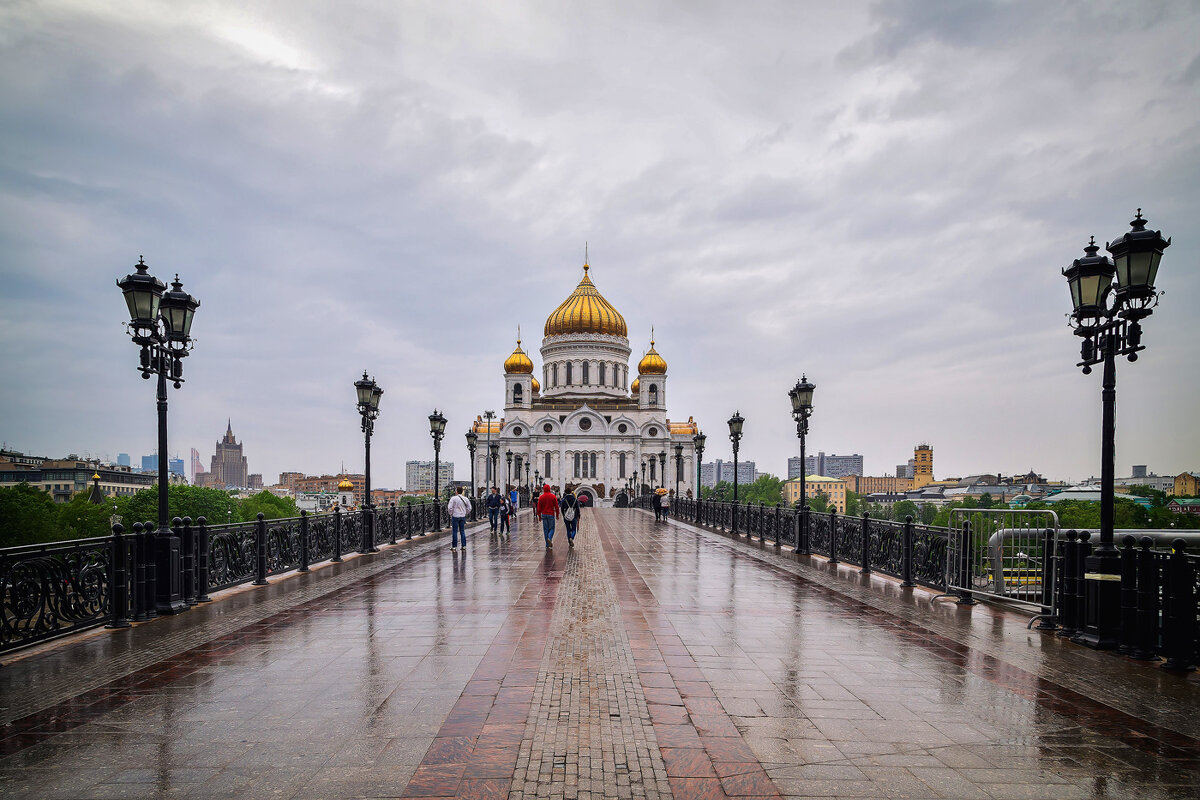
[116,257,200,621]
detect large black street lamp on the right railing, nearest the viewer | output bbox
[1062,209,1171,649]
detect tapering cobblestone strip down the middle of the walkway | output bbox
[509,515,672,800]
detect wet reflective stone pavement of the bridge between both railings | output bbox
[0,510,1200,800]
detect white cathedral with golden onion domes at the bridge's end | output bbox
[473,263,698,506]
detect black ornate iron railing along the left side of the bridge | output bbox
[0,501,445,652]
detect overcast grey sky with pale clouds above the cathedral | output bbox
[0,0,1200,487]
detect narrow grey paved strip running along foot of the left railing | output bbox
[0,515,511,739]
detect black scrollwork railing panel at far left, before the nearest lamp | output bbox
[0,536,112,650]
